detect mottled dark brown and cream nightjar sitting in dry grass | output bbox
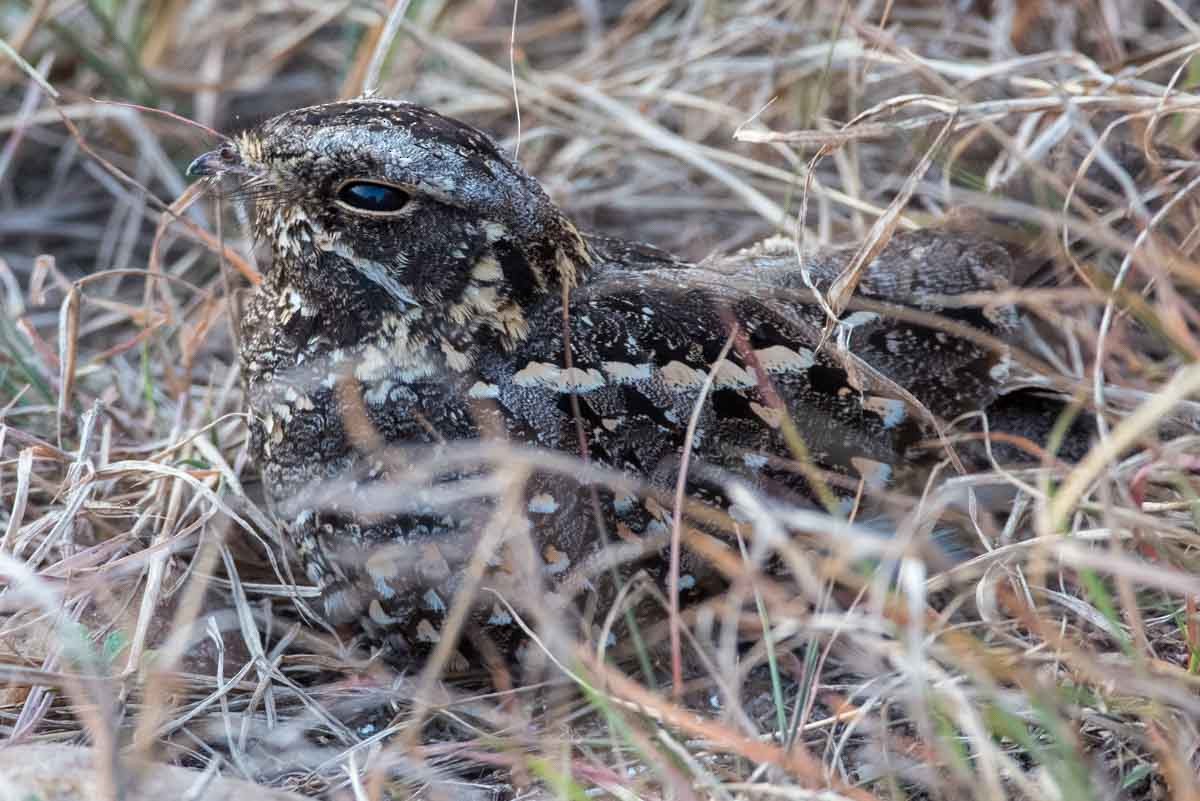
[190,100,1041,660]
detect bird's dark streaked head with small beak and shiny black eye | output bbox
[188,100,589,343]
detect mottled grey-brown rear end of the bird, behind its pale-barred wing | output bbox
[704,229,1020,420]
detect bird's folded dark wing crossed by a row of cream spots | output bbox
[476,271,922,496]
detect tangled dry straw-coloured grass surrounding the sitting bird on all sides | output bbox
[0,0,1200,801]
